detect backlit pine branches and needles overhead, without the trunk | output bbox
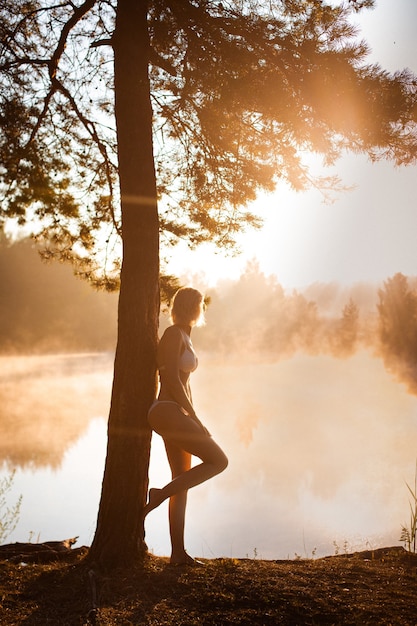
[0,0,416,286]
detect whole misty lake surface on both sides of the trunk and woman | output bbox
[0,351,417,559]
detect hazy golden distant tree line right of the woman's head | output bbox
[196,264,417,392]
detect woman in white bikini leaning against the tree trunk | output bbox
[144,287,228,565]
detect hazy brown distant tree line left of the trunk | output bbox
[0,237,117,354]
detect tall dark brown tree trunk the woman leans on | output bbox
[89,0,159,567]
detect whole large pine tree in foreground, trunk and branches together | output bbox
[0,0,416,565]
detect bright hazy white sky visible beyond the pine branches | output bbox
[169,0,417,288]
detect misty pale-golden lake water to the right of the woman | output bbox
[155,353,417,558]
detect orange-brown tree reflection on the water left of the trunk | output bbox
[0,354,112,469]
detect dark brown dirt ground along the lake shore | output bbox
[0,547,417,626]
